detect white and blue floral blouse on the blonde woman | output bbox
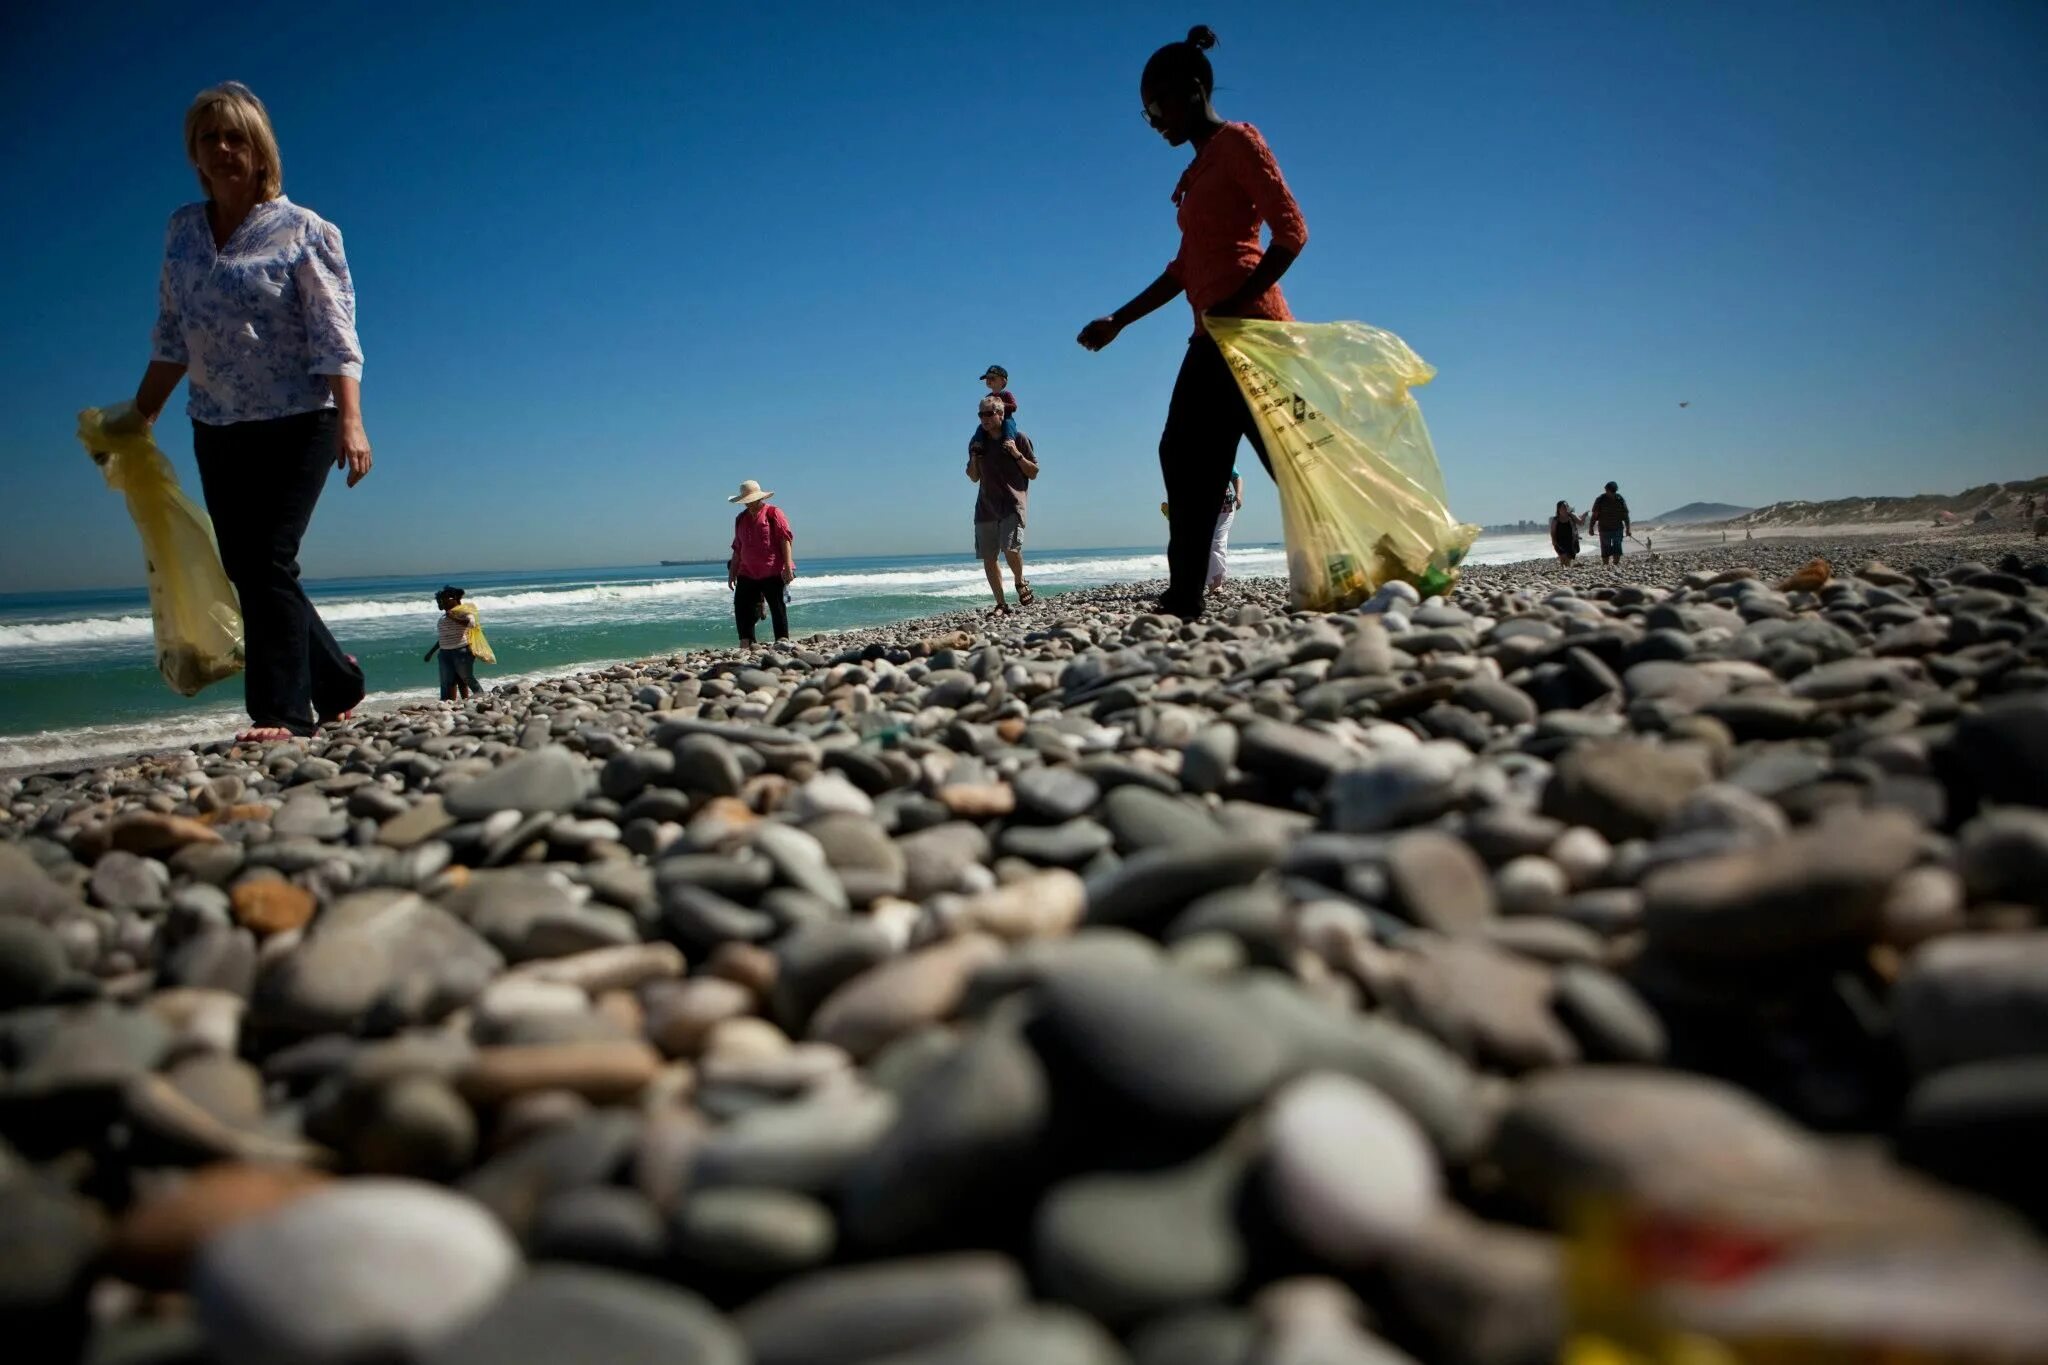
[152,194,362,426]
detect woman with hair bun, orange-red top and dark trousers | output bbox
[1079,25,1309,620]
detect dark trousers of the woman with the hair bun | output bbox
[1159,336,1274,618]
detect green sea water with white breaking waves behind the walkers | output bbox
[0,536,1546,769]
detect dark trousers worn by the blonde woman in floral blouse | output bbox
[193,409,362,735]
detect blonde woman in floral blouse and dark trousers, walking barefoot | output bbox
[135,82,371,743]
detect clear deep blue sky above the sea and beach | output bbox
[0,0,2048,589]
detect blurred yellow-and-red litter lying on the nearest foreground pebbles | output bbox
[1561,1178,2048,1365]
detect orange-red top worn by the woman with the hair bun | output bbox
[1165,123,1309,323]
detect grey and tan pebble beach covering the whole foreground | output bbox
[0,532,2048,1365]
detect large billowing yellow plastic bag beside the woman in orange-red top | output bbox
[1204,317,1479,612]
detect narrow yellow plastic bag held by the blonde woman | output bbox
[78,403,242,696]
